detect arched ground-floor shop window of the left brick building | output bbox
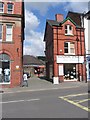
[0,54,10,83]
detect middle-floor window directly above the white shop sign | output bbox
[64,42,75,54]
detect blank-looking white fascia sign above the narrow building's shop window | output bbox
[57,55,84,63]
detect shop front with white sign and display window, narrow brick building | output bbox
[57,56,84,81]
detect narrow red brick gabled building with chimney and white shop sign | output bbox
[44,12,86,84]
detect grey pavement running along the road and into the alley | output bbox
[0,77,88,93]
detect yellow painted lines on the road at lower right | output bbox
[59,93,90,112]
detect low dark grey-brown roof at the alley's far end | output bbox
[23,55,44,66]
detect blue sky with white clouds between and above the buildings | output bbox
[24,0,88,56]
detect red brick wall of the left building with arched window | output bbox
[0,0,24,87]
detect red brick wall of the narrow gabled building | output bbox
[46,17,86,80]
